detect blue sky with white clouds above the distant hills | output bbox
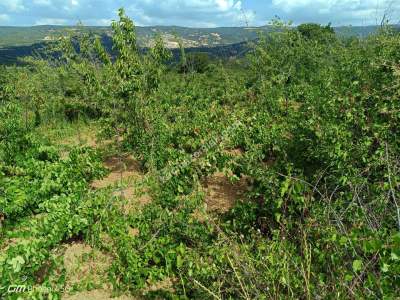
[0,0,400,27]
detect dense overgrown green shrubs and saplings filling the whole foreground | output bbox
[0,10,400,299]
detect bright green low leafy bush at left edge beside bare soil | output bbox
[0,120,105,298]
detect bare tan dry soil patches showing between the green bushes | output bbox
[58,131,247,300]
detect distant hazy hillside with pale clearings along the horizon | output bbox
[0,25,400,64]
